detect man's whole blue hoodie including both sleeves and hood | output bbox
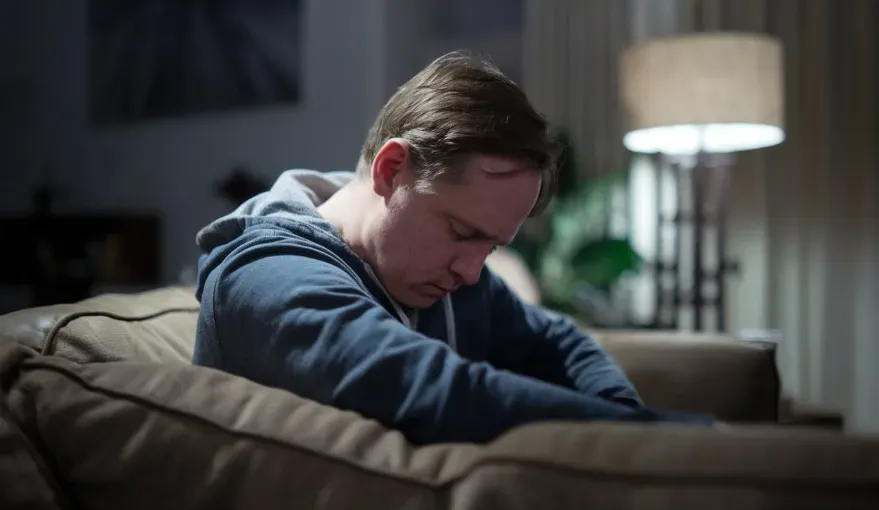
[193,170,711,443]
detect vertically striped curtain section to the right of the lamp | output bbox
[682,0,879,432]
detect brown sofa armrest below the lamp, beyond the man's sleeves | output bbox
[590,330,780,423]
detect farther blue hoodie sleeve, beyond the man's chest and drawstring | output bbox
[483,269,644,408]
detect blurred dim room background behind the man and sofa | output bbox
[0,0,879,431]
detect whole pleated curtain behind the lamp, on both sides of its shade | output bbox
[524,0,879,432]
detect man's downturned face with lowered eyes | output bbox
[373,155,540,308]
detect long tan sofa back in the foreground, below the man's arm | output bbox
[0,343,879,510]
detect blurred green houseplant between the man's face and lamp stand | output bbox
[512,131,642,323]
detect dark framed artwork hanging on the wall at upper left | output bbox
[87,0,303,124]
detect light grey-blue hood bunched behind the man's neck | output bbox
[195,169,354,253]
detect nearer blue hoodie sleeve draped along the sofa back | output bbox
[196,225,672,443]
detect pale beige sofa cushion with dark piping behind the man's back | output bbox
[0,287,198,363]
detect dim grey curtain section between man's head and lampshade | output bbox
[523,0,630,183]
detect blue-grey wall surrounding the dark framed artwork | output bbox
[0,0,384,296]
